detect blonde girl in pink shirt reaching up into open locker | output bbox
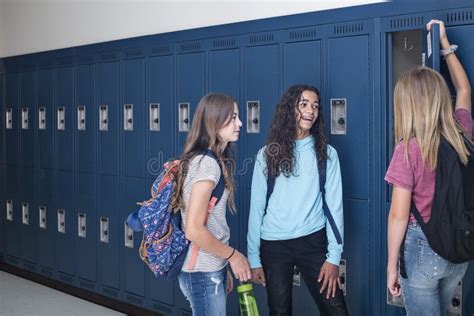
[385,20,472,316]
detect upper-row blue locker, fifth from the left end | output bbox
[76,64,98,173]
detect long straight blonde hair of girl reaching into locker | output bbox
[394,67,469,170]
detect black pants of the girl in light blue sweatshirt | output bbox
[260,229,347,315]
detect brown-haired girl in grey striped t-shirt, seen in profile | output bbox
[172,93,251,316]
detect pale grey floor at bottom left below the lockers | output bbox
[0,271,124,316]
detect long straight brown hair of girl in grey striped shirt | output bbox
[171,93,236,213]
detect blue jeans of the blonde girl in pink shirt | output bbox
[400,223,469,316]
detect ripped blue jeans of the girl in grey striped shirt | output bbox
[178,267,227,316]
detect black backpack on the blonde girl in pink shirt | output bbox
[411,137,474,263]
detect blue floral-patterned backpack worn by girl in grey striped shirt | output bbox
[127,150,225,279]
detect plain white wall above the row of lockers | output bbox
[0,0,382,57]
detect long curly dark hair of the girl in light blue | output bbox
[264,84,328,178]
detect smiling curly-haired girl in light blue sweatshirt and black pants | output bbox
[247,85,347,315]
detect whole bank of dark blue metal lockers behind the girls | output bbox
[0,1,474,315]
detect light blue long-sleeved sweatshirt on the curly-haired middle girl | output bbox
[247,136,344,268]
